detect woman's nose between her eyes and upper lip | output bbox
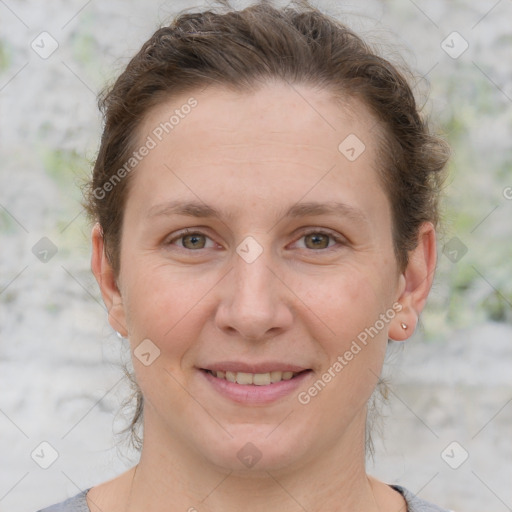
[215,243,293,341]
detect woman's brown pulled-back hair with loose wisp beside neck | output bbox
[84,0,449,447]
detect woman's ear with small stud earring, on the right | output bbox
[388,222,437,341]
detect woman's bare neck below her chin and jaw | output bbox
[126,411,377,512]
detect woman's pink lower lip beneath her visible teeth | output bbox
[200,370,311,405]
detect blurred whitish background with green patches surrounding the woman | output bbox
[0,0,512,512]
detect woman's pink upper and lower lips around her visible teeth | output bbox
[198,365,313,405]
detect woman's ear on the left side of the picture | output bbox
[91,223,128,337]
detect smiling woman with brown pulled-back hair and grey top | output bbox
[38,3,448,512]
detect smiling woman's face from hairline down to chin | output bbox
[100,84,412,471]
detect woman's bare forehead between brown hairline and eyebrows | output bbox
[128,83,389,228]
